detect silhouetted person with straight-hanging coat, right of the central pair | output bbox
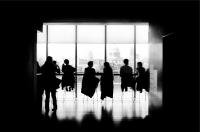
[101,62,114,100]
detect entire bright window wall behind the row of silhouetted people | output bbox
[37,23,149,95]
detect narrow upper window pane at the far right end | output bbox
[136,24,149,43]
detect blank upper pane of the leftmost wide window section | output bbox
[48,25,75,43]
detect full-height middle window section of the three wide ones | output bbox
[77,25,105,73]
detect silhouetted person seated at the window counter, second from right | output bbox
[120,59,134,92]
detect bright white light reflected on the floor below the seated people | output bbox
[42,83,161,124]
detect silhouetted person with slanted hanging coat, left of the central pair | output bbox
[81,61,99,98]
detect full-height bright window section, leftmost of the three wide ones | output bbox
[48,25,75,67]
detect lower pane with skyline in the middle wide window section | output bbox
[77,44,105,73]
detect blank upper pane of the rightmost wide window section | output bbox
[107,25,134,44]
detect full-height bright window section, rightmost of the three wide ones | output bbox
[107,25,134,73]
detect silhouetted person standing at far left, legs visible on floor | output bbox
[41,56,57,112]
